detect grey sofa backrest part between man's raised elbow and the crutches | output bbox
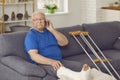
[58,25,84,58]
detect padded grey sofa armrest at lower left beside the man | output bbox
[1,56,46,77]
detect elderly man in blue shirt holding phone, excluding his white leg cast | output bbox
[24,12,94,77]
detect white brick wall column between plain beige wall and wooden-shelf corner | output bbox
[80,0,96,23]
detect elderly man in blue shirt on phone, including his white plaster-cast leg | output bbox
[24,12,115,80]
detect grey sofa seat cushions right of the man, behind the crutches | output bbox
[64,50,120,72]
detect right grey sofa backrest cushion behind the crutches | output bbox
[82,21,120,50]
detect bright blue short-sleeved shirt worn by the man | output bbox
[24,29,62,63]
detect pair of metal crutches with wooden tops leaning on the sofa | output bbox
[69,31,120,78]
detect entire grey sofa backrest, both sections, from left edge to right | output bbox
[0,22,120,59]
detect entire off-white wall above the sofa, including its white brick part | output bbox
[1,0,119,31]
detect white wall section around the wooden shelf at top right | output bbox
[96,0,120,22]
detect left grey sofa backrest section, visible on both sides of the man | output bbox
[0,25,84,60]
